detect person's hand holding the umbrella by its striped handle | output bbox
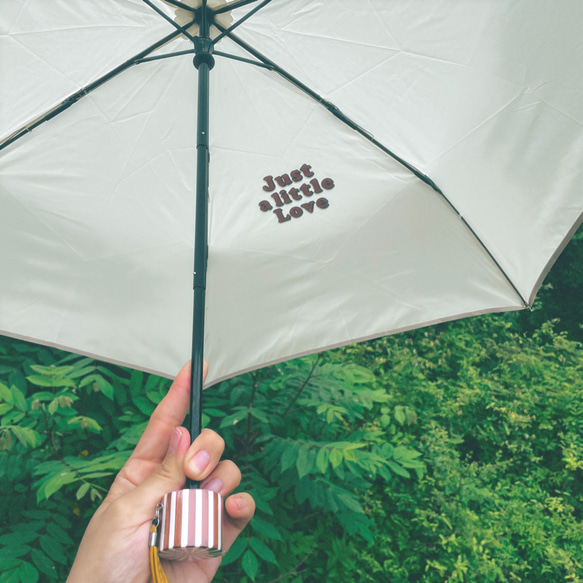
[67,363,255,583]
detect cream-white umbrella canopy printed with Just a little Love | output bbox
[0,0,583,384]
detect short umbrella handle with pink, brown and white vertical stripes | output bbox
[158,489,223,561]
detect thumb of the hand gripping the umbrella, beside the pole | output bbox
[124,427,190,520]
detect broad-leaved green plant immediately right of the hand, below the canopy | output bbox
[205,356,425,581]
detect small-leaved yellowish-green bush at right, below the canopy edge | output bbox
[338,317,583,583]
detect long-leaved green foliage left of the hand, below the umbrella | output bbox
[0,339,168,583]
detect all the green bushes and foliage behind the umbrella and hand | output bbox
[0,229,583,583]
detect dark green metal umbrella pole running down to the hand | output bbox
[187,2,215,488]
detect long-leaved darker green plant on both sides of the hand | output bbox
[0,339,425,583]
